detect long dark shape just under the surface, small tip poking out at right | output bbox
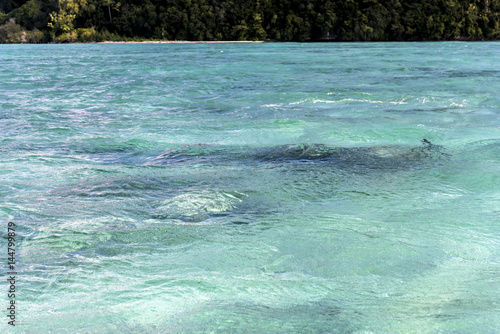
[146,139,450,170]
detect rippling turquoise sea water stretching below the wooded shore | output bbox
[0,42,500,333]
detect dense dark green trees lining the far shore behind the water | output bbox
[0,0,500,42]
